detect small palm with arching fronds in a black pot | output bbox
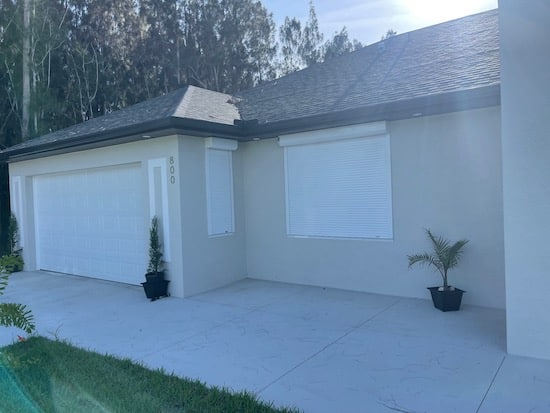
[407,229,468,311]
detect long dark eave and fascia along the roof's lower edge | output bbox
[0,83,500,162]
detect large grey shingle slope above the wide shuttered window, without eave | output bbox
[237,10,500,124]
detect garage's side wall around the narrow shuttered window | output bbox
[179,137,246,296]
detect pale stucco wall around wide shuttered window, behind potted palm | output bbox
[244,107,504,308]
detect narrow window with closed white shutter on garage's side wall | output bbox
[206,138,237,236]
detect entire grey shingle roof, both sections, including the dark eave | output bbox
[0,10,500,159]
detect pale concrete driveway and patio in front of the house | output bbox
[0,272,550,413]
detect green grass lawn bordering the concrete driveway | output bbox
[0,337,302,413]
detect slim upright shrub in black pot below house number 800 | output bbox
[141,216,170,301]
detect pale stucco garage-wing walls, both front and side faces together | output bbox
[5,136,246,297]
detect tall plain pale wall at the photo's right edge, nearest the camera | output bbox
[499,0,550,359]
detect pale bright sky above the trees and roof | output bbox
[262,0,498,44]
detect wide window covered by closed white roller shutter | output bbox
[280,122,393,239]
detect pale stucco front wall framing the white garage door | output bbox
[9,136,183,296]
